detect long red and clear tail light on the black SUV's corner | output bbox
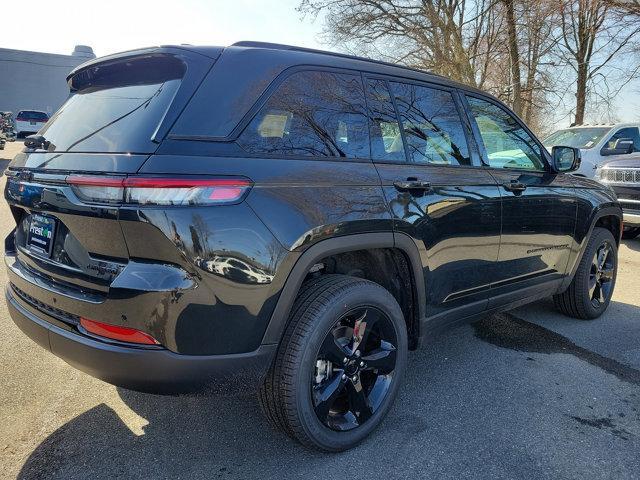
[66,175,252,205]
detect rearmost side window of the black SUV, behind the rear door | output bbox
[238,72,369,158]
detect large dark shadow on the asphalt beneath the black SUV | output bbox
[13,304,640,479]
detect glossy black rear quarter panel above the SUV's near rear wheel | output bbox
[136,155,392,353]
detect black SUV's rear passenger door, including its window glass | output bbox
[366,77,500,324]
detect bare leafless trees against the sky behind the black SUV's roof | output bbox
[298,0,640,130]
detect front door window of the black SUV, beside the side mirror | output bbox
[468,97,545,171]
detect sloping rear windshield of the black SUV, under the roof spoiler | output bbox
[39,55,185,153]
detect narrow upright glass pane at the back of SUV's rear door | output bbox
[367,79,406,161]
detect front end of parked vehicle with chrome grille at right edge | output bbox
[596,158,640,239]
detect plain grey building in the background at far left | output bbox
[0,45,95,115]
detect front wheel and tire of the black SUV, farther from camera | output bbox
[553,227,618,320]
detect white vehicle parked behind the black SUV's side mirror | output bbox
[543,123,640,178]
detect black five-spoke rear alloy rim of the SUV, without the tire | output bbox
[311,307,398,431]
